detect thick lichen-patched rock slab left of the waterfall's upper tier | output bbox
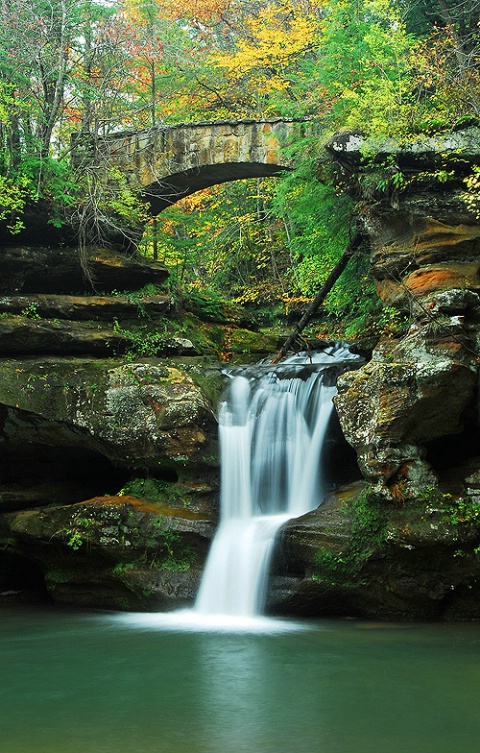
[0,359,217,475]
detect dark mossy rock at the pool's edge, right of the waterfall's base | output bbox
[269,486,480,620]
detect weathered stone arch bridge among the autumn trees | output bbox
[100,118,314,215]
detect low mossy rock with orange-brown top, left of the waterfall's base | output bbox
[0,495,215,610]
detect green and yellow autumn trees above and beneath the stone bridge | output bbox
[0,0,480,334]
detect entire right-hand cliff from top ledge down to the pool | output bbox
[262,128,480,619]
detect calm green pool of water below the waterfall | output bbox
[0,607,480,753]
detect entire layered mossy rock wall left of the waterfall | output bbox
[0,247,221,609]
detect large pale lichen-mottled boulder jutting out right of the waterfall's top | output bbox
[335,344,477,482]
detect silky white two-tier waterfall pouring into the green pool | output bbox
[195,346,358,617]
